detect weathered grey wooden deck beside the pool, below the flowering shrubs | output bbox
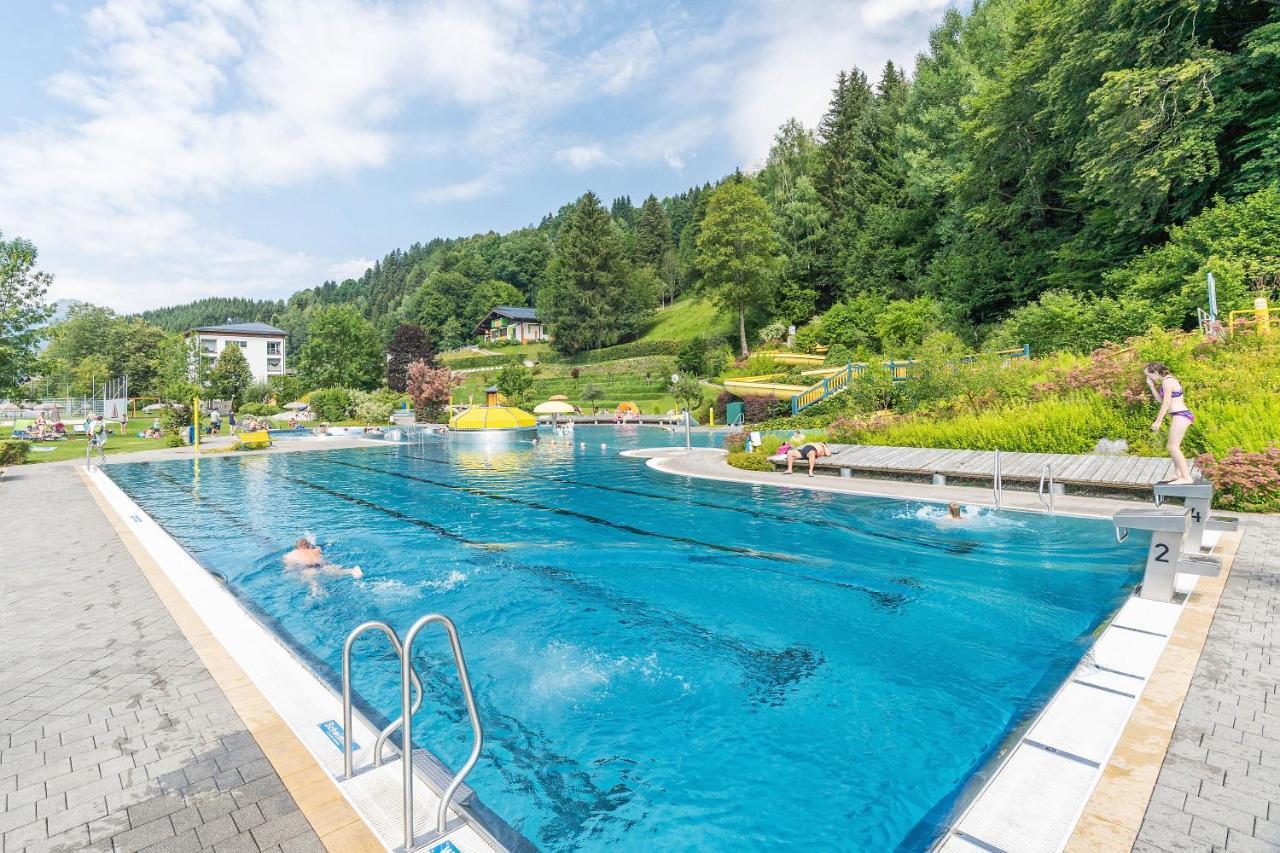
[773,444,1194,489]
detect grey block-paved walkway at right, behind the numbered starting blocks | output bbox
[1133,515,1280,853]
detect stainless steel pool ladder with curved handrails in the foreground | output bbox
[342,613,484,850]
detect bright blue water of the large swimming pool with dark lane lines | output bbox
[106,428,1144,850]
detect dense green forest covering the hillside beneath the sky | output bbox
[132,0,1280,346]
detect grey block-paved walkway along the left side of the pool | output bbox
[0,464,324,853]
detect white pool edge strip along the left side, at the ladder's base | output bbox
[90,469,519,853]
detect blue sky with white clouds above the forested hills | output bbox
[0,0,952,311]
